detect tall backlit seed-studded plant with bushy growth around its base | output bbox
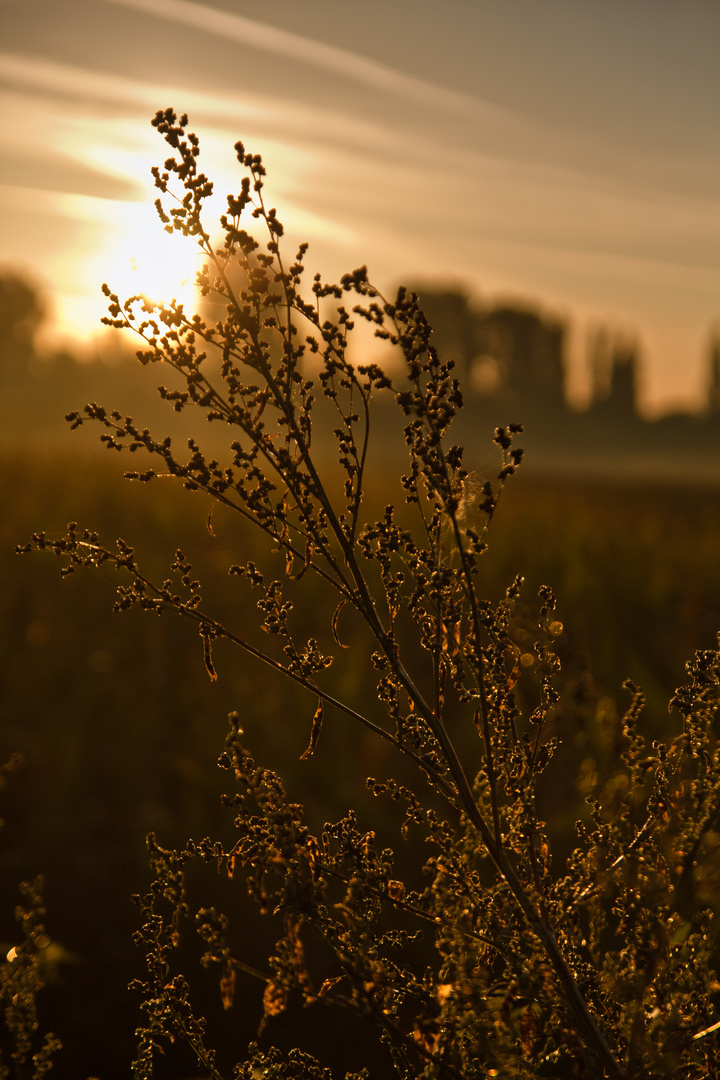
[16,109,720,1080]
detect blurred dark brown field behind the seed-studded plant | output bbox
[0,450,720,1080]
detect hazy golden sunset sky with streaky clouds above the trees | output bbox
[0,0,720,415]
